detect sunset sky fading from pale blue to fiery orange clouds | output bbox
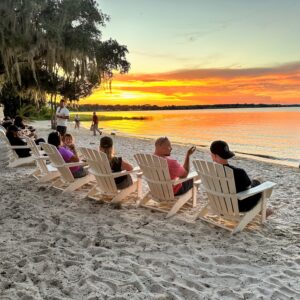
[81,0,300,105]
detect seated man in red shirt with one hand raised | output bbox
[154,137,196,196]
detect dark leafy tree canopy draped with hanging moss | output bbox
[0,0,130,119]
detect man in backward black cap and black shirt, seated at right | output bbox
[210,141,272,216]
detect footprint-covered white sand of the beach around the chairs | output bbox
[0,122,300,300]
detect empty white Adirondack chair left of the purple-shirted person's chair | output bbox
[26,138,60,182]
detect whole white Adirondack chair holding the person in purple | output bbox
[40,143,94,193]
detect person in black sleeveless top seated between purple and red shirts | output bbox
[100,136,133,190]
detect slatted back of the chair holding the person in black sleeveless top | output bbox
[79,147,118,194]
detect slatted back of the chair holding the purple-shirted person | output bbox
[40,143,75,183]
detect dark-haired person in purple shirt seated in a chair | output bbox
[48,131,87,178]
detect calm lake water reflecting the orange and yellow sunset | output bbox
[83,108,300,166]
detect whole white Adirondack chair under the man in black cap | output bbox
[193,160,276,234]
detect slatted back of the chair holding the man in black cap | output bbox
[193,160,239,218]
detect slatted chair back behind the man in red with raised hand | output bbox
[134,153,175,200]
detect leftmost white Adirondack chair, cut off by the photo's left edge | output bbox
[0,130,35,168]
